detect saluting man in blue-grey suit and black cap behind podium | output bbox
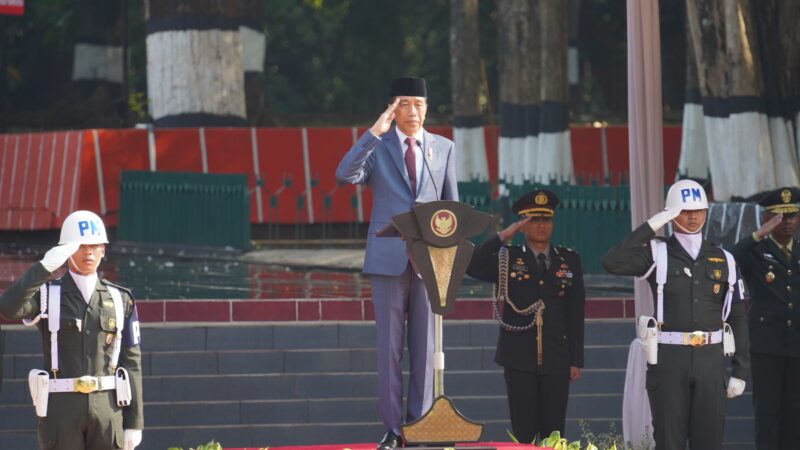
[336,78,458,450]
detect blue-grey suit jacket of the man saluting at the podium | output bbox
[336,128,458,276]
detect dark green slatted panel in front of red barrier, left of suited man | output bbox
[117,171,250,249]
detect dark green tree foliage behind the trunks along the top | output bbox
[0,0,684,130]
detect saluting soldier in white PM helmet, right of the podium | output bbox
[603,180,750,450]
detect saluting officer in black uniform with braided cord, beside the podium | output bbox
[467,189,586,442]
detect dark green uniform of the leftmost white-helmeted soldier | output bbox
[0,263,144,450]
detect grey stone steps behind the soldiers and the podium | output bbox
[0,320,753,450]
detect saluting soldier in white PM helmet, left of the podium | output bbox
[0,211,144,450]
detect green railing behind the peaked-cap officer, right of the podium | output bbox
[458,182,631,273]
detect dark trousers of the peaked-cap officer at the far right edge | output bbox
[750,353,800,450]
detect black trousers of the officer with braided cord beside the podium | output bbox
[505,368,569,444]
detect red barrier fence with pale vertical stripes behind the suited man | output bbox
[0,126,681,230]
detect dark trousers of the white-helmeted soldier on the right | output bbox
[646,344,727,450]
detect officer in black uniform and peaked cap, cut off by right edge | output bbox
[733,187,800,450]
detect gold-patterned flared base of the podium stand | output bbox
[400,395,484,449]
